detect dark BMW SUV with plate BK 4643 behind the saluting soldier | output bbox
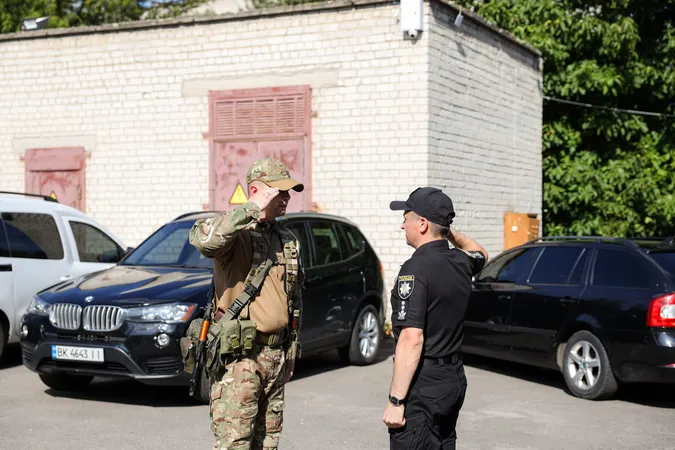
[21,212,384,403]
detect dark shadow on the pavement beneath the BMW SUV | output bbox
[43,338,392,408]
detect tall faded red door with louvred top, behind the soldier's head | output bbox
[209,86,311,212]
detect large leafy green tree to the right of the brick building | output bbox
[456,0,675,236]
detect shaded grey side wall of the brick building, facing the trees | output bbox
[429,5,542,257]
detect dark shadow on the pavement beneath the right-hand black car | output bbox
[463,353,675,409]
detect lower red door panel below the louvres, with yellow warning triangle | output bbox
[214,139,307,212]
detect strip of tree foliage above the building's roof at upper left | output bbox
[0,0,206,33]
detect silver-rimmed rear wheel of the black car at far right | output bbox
[562,331,619,400]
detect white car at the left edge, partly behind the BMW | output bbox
[0,192,130,359]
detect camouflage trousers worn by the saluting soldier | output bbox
[210,346,286,450]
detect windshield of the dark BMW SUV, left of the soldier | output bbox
[122,220,213,269]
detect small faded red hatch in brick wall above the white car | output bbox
[25,148,86,211]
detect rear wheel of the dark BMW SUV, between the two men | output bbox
[338,305,383,366]
